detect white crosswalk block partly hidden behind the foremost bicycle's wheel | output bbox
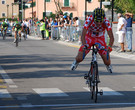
[83,87,123,95]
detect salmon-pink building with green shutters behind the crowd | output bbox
[25,0,111,19]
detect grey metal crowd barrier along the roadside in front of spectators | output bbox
[31,24,135,51]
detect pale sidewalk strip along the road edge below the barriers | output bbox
[28,36,135,60]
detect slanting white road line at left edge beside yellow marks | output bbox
[0,66,17,87]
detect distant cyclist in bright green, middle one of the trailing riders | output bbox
[13,21,23,43]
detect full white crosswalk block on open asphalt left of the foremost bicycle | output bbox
[33,88,68,97]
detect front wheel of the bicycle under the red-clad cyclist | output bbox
[91,62,98,103]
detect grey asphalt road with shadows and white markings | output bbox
[0,37,135,110]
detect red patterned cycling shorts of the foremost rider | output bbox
[79,36,107,55]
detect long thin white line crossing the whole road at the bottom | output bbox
[0,103,135,108]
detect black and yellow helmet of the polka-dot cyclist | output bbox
[93,8,105,22]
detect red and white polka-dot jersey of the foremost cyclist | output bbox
[83,15,112,37]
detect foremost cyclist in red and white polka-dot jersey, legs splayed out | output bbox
[71,8,114,72]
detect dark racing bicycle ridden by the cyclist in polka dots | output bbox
[83,44,109,103]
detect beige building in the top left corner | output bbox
[0,0,19,18]
